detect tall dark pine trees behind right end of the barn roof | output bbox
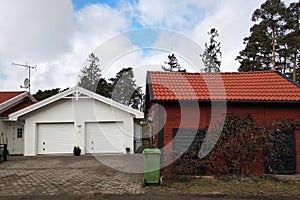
[236,0,300,81]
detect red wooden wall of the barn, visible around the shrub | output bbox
[155,102,300,174]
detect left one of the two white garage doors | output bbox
[38,123,77,154]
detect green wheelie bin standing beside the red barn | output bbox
[143,148,162,187]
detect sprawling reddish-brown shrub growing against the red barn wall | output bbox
[163,115,298,180]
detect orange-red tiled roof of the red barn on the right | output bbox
[148,71,300,101]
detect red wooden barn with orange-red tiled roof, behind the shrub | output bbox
[146,71,300,174]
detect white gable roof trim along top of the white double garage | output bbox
[9,86,144,121]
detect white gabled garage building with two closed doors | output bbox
[9,86,144,156]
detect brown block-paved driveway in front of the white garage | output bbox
[0,155,143,199]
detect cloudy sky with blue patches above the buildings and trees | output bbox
[0,0,293,92]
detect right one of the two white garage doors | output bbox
[86,122,125,153]
